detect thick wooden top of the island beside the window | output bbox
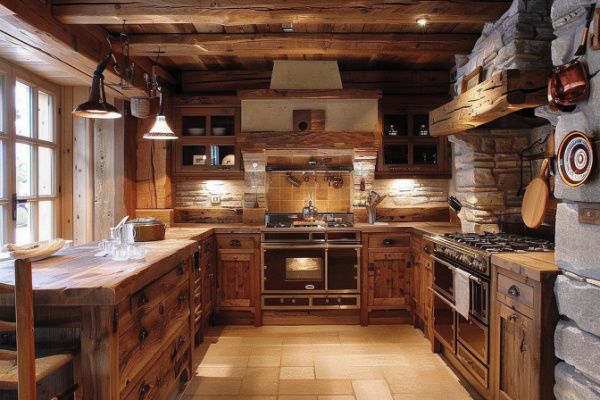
[0,239,197,306]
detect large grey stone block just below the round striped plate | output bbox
[556,202,600,279]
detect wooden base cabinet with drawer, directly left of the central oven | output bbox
[216,234,260,324]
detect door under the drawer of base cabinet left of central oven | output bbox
[217,253,254,307]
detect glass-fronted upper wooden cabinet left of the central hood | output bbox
[173,107,241,179]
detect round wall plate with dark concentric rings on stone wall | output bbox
[558,131,594,187]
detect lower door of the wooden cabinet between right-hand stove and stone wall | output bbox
[495,302,539,400]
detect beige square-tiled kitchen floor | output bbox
[183,325,472,400]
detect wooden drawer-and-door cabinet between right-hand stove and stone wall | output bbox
[490,254,558,400]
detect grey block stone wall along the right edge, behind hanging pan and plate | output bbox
[539,0,600,400]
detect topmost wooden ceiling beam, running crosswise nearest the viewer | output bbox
[53,0,511,25]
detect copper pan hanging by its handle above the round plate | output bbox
[548,3,596,112]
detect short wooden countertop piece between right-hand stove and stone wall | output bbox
[492,251,560,281]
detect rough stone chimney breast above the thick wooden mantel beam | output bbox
[454,0,553,93]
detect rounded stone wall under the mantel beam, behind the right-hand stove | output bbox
[450,125,551,232]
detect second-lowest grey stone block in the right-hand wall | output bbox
[554,321,600,382]
